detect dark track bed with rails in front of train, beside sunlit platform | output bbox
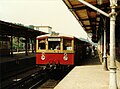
[1,66,73,89]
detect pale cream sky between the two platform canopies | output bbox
[0,0,87,38]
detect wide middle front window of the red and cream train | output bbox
[48,41,60,50]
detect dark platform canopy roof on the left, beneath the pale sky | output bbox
[0,20,46,38]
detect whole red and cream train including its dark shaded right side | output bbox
[36,33,86,65]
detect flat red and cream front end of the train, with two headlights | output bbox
[36,34,74,65]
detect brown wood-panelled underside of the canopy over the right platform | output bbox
[63,0,120,41]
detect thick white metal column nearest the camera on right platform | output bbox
[109,0,118,89]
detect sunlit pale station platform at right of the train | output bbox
[54,54,120,89]
